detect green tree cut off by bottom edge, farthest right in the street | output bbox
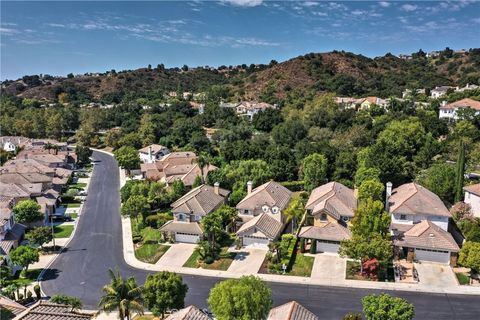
[362,293,415,320]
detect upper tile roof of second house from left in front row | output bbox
[236,181,292,212]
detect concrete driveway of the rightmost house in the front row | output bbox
[414,262,457,288]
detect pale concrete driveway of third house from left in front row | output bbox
[311,253,347,284]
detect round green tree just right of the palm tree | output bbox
[143,271,188,319]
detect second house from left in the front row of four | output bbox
[236,181,292,247]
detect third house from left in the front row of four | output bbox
[298,182,357,253]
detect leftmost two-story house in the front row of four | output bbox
[160,182,230,243]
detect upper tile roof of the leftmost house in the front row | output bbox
[171,184,230,216]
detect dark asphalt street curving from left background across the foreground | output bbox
[42,152,480,320]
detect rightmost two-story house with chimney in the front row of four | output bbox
[385,182,459,265]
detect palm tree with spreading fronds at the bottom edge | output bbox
[98,269,143,320]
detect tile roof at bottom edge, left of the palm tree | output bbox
[14,300,93,320]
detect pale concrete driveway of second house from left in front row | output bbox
[228,247,267,274]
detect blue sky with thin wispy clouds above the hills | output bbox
[0,0,480,80]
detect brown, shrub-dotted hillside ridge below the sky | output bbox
[2,49,480,102]
